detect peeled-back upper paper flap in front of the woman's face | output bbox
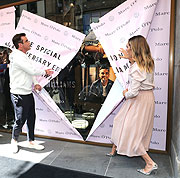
[91,0,157,88]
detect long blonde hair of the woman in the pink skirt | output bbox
[128,35,154,73]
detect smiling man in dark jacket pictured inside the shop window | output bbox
[89,66,114,103]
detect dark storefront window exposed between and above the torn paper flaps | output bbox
[0,0,122,139]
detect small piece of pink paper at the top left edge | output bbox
[0,7,15,47]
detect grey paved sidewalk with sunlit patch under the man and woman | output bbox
[0,132,173,178]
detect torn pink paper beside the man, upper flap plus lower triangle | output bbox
[16,11,85,140]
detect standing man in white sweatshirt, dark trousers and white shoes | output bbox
[9,33,53,153]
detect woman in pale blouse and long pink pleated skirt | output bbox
[107,35,158,175]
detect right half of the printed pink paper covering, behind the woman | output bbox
[87,0,171,151]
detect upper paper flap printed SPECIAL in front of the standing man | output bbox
[13,10,85,86]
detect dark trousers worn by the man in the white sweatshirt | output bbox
[11,94,36,141]
